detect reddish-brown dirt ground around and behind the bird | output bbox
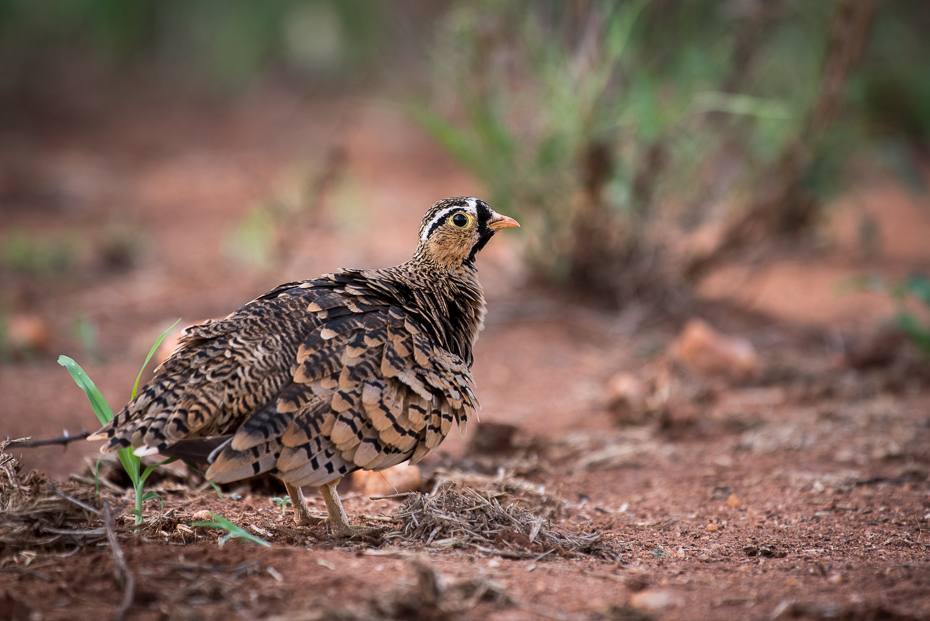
[0,86,930,620]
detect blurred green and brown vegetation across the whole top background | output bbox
[0,0,930,307]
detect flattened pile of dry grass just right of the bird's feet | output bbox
[384,481,621,562]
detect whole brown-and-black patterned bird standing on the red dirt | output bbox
[88,196,520,537]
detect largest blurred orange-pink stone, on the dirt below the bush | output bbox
[673,319,759,381]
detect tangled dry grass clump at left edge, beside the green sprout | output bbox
[0,440,106,553]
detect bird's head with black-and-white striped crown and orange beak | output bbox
[417,196,520,269]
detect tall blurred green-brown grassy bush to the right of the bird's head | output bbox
[419,0,930,305]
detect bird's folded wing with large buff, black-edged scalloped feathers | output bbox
[207,302,477,486]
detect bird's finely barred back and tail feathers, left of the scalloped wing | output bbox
[90,283,325,453]
